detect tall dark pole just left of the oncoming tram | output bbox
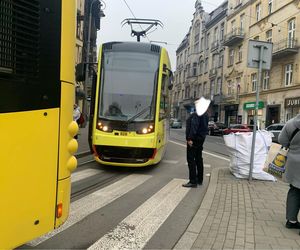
[82,0,98,118]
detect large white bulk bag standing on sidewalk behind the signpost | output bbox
[224,130,276,181]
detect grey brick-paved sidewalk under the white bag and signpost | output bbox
[175,168,300,249]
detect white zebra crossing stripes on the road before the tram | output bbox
[25,164,208,250]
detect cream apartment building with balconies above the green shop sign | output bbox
[223,0,300,128]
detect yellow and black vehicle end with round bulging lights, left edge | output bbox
[0,0,78,249]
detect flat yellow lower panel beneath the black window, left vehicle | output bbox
[0,108,59,249]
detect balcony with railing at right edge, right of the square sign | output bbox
[272,39,299,59]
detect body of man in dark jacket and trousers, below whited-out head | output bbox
[182,109,208,187]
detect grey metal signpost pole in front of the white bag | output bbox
[249,45,265,181]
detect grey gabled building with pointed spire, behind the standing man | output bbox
[172,0,207,121]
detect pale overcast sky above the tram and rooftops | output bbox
[98,0,224,70]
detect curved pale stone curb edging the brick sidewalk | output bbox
[173,168,227,249]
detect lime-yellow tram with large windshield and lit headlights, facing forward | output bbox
[89,42,172,167]
